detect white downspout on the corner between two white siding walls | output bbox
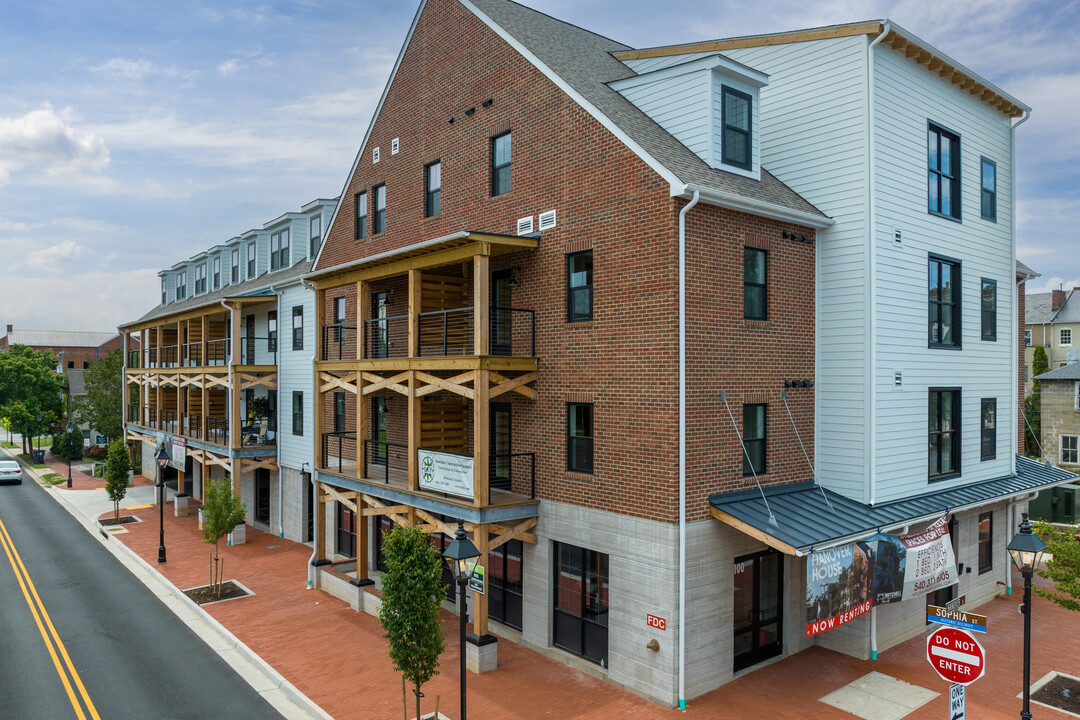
[865,22,892,507]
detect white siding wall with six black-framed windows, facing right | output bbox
[874,42,1016,502]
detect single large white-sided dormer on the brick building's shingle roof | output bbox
[609,53,769,180]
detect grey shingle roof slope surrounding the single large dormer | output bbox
[471,0,826,218]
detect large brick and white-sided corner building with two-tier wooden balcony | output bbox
[307,0,1075,705]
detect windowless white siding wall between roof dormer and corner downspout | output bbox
[725,37,868,499]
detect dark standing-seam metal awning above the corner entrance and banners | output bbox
[708,456,1078,556]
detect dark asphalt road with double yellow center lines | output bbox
[0,480,281,720]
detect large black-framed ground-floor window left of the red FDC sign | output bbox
[553,543,608,663]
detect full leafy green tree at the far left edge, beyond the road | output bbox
[0,345,67,452]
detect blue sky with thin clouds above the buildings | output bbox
[0,0,1080,330]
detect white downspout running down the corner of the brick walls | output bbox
[678,185,701,710]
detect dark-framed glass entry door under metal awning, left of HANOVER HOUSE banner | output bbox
[733,551,784,673]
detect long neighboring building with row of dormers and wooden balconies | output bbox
[121,200,336,542]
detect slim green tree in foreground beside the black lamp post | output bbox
[379,525,447,718]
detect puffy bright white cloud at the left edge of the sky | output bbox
[0,104,109,188]
